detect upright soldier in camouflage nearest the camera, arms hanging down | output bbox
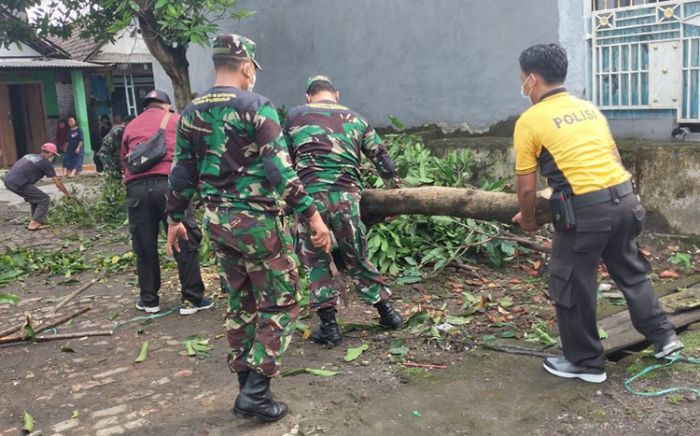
[167,35,330,422]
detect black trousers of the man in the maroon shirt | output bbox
[126,176,204,306]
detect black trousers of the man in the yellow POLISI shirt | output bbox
[549,194,675,369]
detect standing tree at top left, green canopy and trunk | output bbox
[0,0,254,108]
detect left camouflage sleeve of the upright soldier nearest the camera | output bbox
[165,116,198,222]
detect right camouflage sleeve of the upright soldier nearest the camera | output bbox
[254,104,316,218]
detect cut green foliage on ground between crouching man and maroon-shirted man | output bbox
[49,177,127,228]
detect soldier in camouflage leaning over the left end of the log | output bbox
[284,76,401,345]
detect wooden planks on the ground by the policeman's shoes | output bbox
[599,285,700,354]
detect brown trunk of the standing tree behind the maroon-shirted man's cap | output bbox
[137,4,192,111]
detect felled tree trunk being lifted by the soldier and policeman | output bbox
[360,186,552,225]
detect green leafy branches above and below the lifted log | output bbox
[363,133,518,278]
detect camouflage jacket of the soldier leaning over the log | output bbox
[284,101,400,193]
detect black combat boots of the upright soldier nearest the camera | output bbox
[233,371,289,422]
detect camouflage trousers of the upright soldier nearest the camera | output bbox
[205,208,299,377]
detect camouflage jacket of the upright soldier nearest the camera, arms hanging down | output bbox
[167,87,316,221]
